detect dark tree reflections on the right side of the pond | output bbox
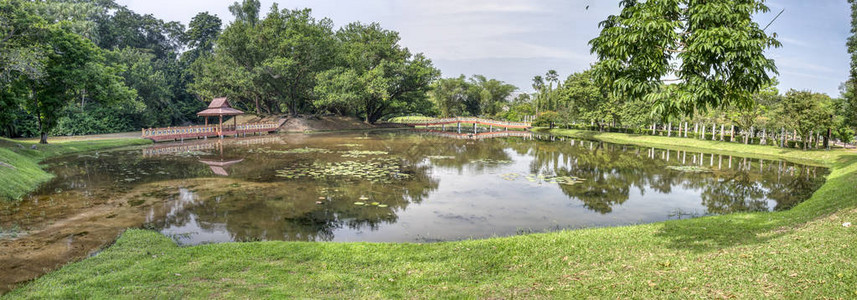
[508,136,826,214]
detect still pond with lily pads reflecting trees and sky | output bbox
[0,130,828,288]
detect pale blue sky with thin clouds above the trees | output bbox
[117,0,851,97]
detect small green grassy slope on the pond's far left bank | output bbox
[0,138,151,201]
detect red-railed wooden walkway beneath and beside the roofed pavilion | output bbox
[142,119,286,142]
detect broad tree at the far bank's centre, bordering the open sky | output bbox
[315,22,439,123]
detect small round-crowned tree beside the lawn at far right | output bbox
[778,90,833,150]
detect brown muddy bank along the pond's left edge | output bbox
[0,178,276,294]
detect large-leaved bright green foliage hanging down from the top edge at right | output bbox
[589,0,780,117]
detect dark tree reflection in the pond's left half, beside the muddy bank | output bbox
[158,162,438,241]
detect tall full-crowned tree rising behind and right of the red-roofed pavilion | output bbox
[190,6,337,115]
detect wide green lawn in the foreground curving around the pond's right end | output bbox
[7,131,857,299]
